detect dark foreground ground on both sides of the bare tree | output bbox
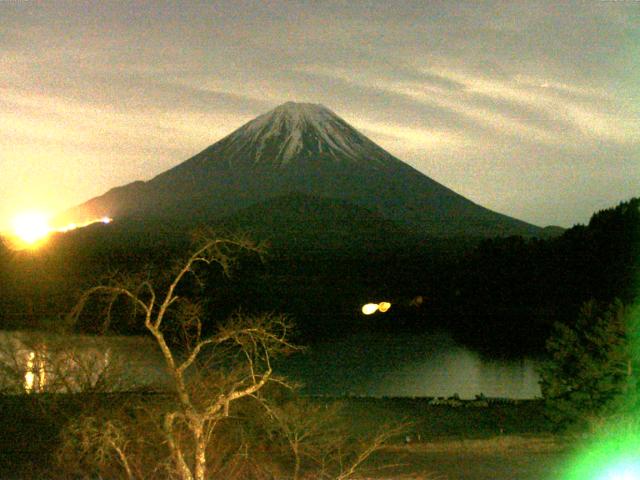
[0,396,569,480]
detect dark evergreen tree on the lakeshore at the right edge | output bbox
[540,300,640,429]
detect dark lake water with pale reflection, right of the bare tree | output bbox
[283,333,540,399]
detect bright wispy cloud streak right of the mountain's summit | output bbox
[298,65,640,146]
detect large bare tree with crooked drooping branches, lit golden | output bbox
[72,239,295,480]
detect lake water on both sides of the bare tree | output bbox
[0,331,540,399]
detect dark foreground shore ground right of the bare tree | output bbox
[343,398,571,480]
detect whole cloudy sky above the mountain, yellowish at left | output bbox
[0,0,640,230]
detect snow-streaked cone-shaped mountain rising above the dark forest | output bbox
[58,102,542,242]
